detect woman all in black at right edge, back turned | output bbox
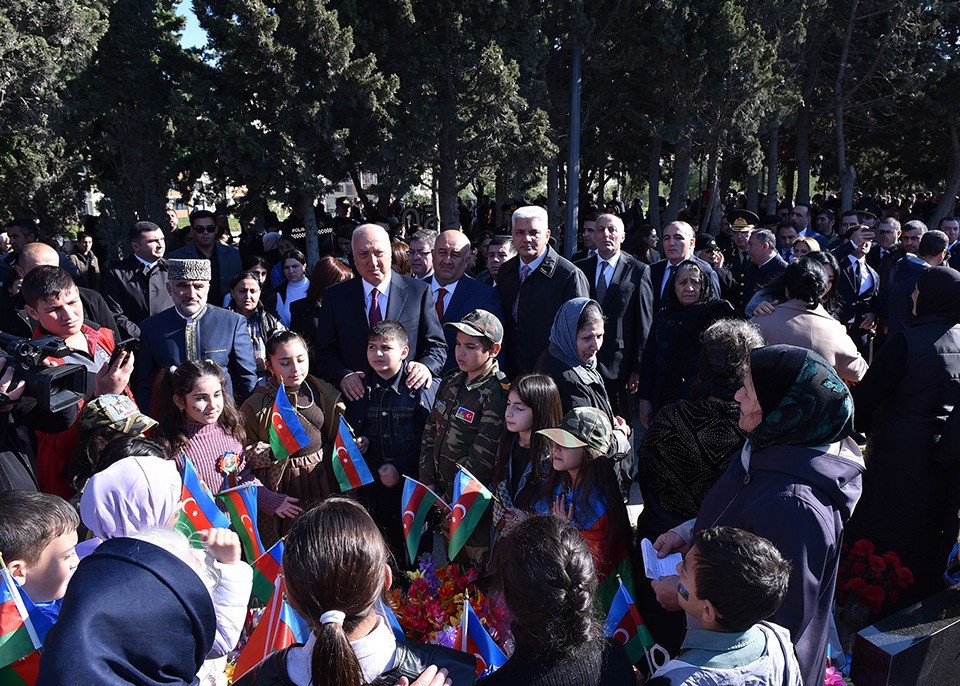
[850,267,960,608]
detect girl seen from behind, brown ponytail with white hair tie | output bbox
[236,497,476,686]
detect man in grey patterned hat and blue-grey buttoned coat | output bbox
[136,260,257,411]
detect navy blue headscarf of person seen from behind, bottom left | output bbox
[37,538,217,686]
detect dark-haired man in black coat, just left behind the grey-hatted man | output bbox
[103,222,173,338]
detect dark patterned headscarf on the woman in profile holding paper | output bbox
[747,345,853,450]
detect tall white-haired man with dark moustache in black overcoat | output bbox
[497,205,590,379]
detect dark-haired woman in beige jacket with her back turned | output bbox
[753,259,867,382]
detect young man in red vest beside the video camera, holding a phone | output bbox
[20,266,133,500]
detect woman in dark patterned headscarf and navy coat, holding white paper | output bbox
[652,345,864,684]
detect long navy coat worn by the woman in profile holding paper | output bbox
[688,439,864,684]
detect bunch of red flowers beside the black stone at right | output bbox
[837,538,914,616]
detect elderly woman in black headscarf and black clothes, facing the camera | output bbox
[637,260,739,427]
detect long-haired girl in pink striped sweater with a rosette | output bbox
[154,360,300,517]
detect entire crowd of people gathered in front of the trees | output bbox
[0,187,960,686]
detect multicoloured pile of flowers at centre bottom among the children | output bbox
[388,554,513,655]
